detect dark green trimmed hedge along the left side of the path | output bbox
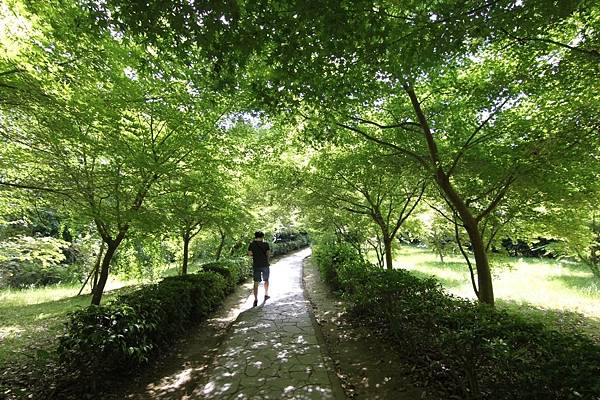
[42,258,249,399]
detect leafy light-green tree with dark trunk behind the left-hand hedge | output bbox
[1,2,230,304]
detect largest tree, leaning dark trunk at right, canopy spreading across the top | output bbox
[7,0,600,304]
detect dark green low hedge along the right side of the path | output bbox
[313,241,600,400]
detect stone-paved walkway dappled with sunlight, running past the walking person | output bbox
[199,249,344,400]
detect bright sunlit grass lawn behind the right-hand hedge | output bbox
[394,246,600,342]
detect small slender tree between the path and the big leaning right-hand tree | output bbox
[302,143,425,269]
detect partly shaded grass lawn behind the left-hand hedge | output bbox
[0,280,134,368]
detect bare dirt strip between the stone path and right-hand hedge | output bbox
[304,258,437,400]
